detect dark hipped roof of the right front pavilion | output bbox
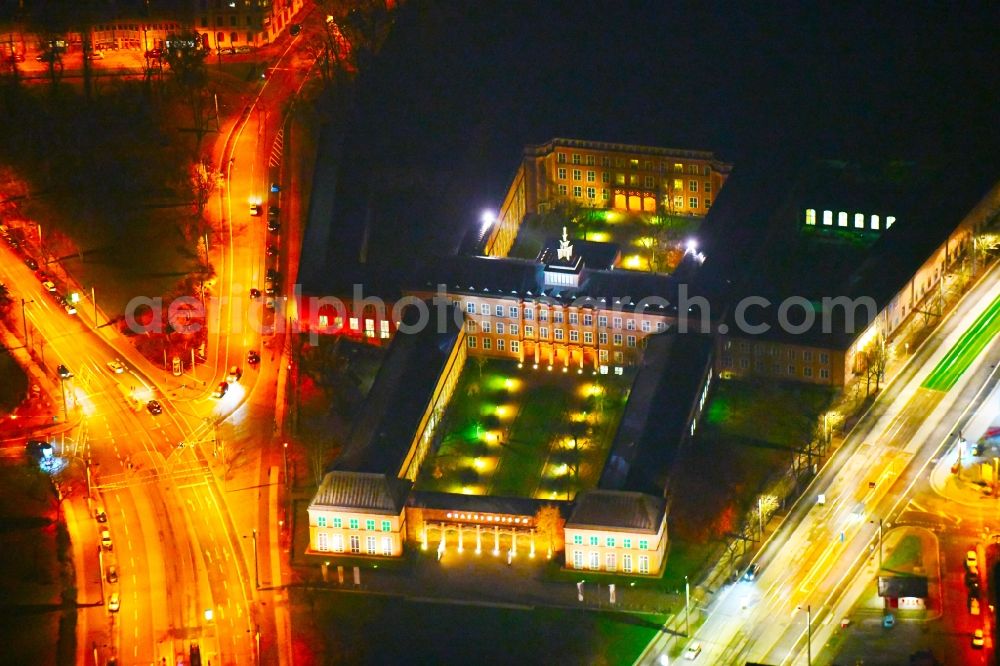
[566,490,667,534]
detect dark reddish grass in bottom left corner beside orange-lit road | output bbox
[0,461,66,664]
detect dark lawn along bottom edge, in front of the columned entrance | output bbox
[292,590,663,665]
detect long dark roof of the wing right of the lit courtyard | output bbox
[598,331,713,495]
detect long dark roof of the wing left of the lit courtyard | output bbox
[333,305,461,476]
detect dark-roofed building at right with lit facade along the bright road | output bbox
[700,161,1000,386]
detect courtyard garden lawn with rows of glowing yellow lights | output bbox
[417,359,631,499]
